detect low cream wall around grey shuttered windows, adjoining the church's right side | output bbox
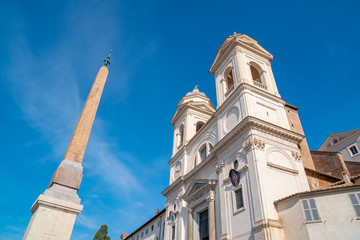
[277,187,360,240]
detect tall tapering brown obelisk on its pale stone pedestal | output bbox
[23,52,111,240]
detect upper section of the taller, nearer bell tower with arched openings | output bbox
[210,33,290,136]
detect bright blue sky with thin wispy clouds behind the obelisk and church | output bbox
[0,0,360,240]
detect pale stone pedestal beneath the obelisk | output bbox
[23,184,83,240]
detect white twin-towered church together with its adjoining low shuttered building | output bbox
[123,33,360,240]
